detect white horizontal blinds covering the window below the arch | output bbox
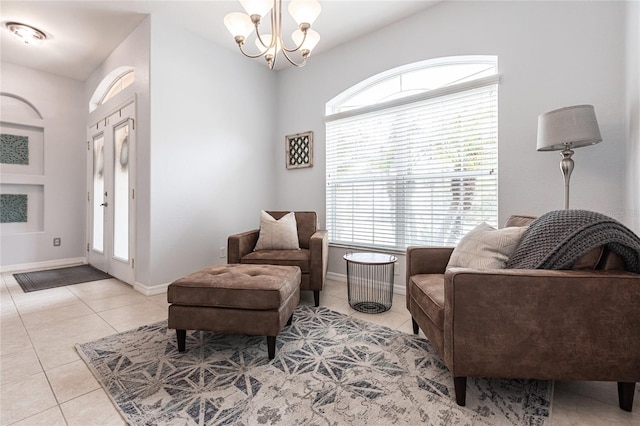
[326,76,498,251]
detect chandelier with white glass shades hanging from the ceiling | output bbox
[224,0,321,69]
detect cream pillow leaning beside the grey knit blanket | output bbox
[447,223,527,269]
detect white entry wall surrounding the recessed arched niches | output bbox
[0,62,86,270]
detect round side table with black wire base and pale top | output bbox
[344,253,398,314]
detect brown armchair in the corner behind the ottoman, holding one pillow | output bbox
[227,211,329,306]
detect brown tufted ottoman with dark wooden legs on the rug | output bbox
[167,264,301,359]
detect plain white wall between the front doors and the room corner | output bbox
[144,16,277,286]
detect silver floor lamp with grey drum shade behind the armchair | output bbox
[538,105,602,209]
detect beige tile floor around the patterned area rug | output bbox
[0,273,640,426]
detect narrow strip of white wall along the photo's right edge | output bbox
[625,1,640,234]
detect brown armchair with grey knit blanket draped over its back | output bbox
[406,216,640,411]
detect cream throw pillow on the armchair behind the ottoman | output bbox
[254,210,300,251]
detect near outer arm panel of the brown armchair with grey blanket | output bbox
[444,268,640,382]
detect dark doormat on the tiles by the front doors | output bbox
[13,265,111,293]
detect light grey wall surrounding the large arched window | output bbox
[273,1,626,283]
